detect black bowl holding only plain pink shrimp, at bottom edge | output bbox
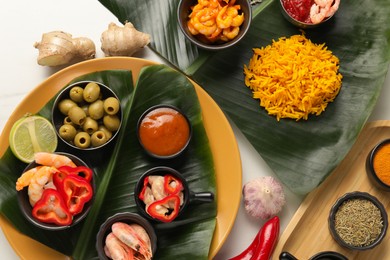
[96,212,157,260]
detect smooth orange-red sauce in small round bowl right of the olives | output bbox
[138,107,190,156]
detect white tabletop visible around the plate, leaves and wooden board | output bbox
[0,0,390,260]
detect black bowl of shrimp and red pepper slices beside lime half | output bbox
[16,152,95,231]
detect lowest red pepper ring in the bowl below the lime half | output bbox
[32,189,73,226]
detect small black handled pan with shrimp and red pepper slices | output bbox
[134,166,214,223]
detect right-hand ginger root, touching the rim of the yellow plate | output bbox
[100,22,150,56]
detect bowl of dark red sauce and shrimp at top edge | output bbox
[279,0,341,29]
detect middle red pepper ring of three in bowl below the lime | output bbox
[59,174,93,215]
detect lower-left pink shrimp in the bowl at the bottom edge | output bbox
[104,233,134,260]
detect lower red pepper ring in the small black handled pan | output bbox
[146,195,180,222]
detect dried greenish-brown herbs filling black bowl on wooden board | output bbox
[335,199,383,247]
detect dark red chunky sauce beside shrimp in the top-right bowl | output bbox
[282,0,314,23]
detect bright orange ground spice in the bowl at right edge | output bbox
[373,143,390,185]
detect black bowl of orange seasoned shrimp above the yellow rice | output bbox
[177,0,252,51]
